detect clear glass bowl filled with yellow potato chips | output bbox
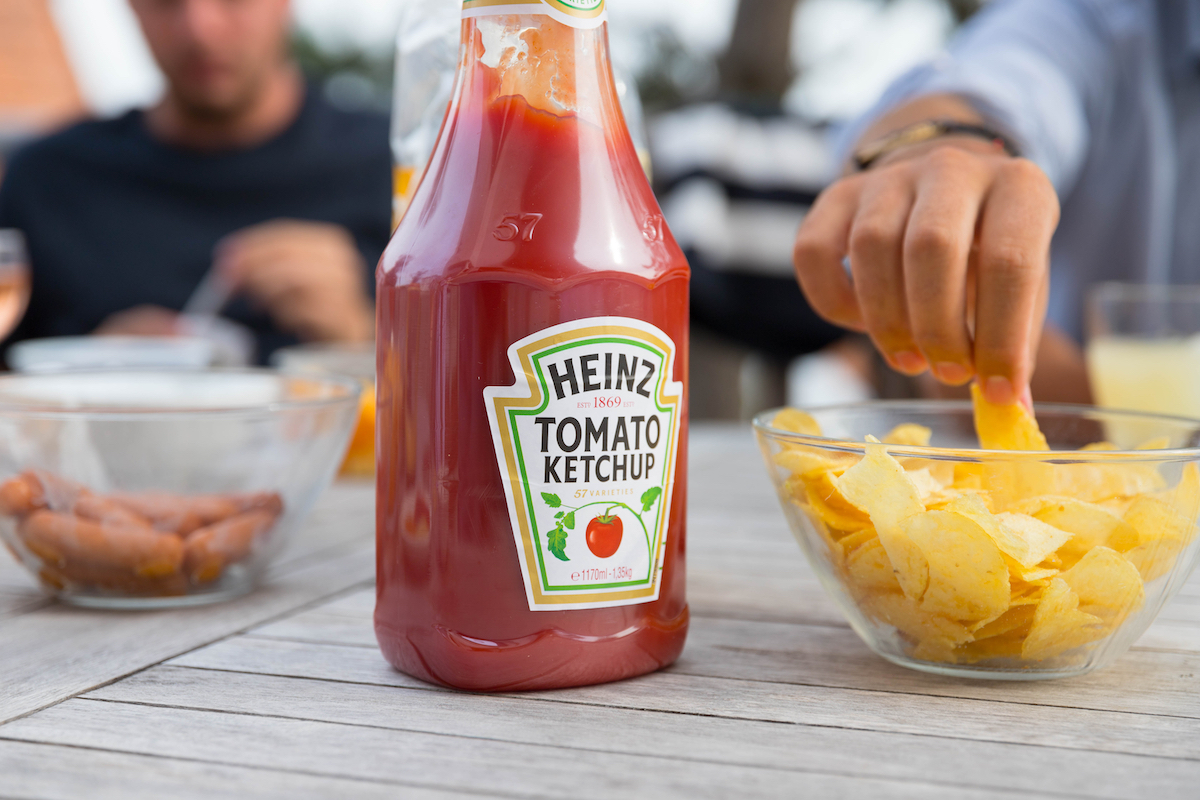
[755,391,1200,680]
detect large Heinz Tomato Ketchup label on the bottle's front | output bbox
[484,317,683,610]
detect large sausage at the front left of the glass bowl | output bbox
[17,510,184,578]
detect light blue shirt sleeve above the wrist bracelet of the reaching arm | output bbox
[842,0,1134,196]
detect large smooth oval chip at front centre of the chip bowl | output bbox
[904,511,1009,620]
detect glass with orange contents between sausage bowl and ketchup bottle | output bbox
[271,342,376,476]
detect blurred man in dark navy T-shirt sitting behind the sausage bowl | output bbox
[0,0,391,359]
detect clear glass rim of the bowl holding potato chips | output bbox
[751,399,1200,464]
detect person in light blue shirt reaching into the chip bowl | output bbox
[794,0,1200,410]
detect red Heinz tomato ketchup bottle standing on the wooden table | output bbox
[376,0,689,691]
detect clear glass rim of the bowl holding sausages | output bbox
[0,367,362,421]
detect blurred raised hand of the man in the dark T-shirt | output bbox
[216,219,374,342]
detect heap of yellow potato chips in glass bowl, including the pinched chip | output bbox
[768,385,1200,672]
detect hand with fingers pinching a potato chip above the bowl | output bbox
[793,138,1058,403]
